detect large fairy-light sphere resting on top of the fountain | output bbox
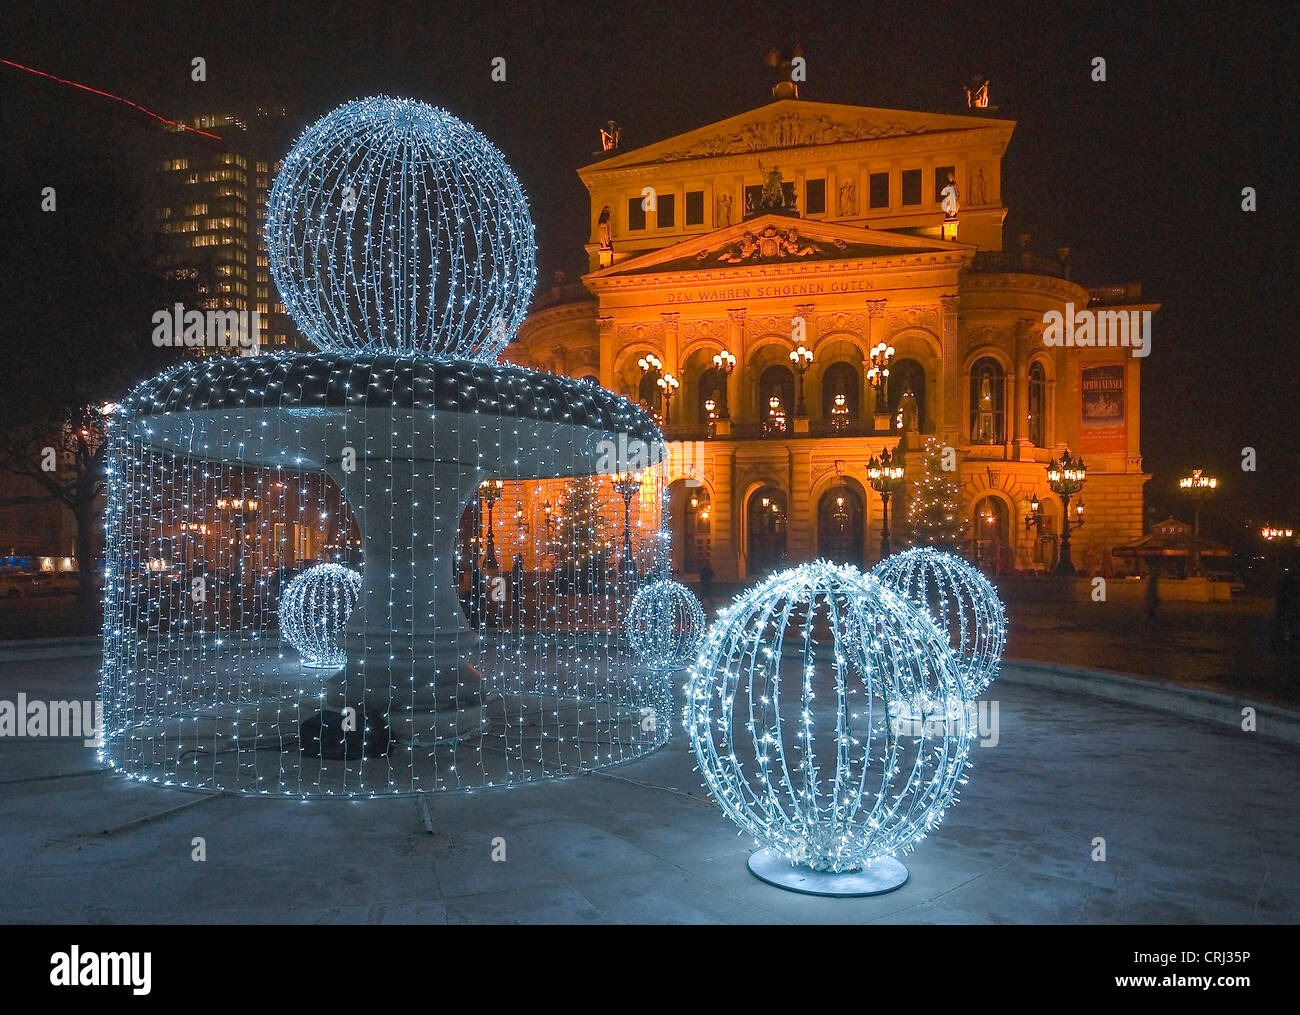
[267,96,537,361]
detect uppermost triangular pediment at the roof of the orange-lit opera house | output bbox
[580,99,1015,175]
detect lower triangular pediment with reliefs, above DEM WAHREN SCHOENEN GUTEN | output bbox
[586,213,975,282]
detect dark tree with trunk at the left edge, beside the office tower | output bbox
[0,123,192,632]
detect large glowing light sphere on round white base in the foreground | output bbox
[685,560,974,895]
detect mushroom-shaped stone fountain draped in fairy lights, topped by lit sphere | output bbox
[94,97,672,797]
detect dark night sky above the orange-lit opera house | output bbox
[0,1,1300,543]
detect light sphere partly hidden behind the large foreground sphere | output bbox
[871,546,1006,698]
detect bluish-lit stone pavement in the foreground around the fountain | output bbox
[0,659,1300,924]
